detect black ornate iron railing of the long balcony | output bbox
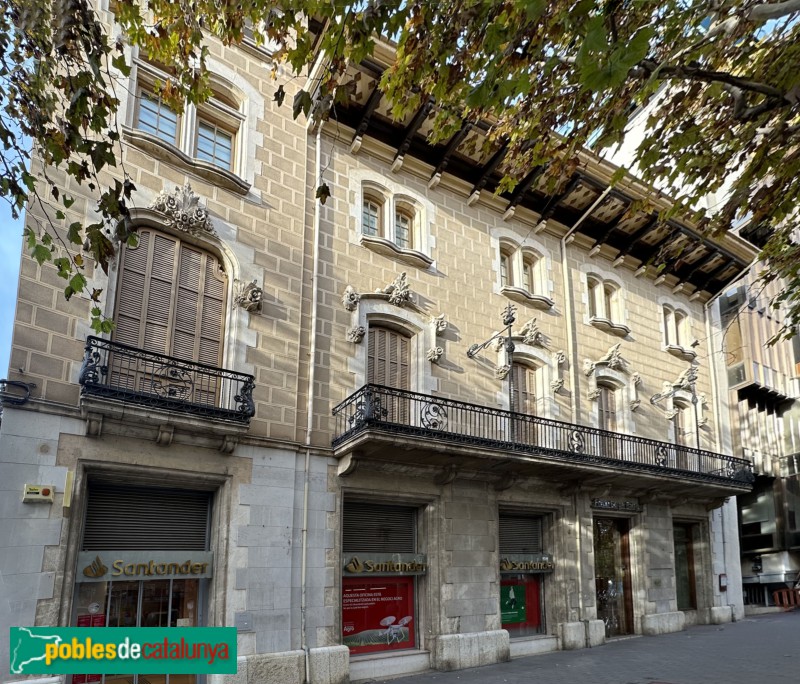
[333,385,754,484]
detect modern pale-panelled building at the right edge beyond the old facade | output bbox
[713,264,800,606]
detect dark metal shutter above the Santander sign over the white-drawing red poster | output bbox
[342,501,417,553]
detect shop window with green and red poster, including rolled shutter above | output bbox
[499,513,545,638]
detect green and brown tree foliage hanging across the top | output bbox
[0,0,800,334]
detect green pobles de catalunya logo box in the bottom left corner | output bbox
[10,627,236,675]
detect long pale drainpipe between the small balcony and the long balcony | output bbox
[300,124,322,684]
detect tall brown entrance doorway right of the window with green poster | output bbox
[594,518,633,637]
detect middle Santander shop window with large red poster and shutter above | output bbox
[342,500,424,655]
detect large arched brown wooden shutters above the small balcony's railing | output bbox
[114,229,226,366]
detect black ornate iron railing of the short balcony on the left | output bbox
[78,336,255,423]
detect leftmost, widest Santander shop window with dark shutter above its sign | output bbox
[71,480,214,684]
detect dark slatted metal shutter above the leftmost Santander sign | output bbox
[83,483,211,551]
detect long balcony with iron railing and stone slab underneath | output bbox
[333,385,754,498]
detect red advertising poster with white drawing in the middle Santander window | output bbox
[342,577,416,653]
